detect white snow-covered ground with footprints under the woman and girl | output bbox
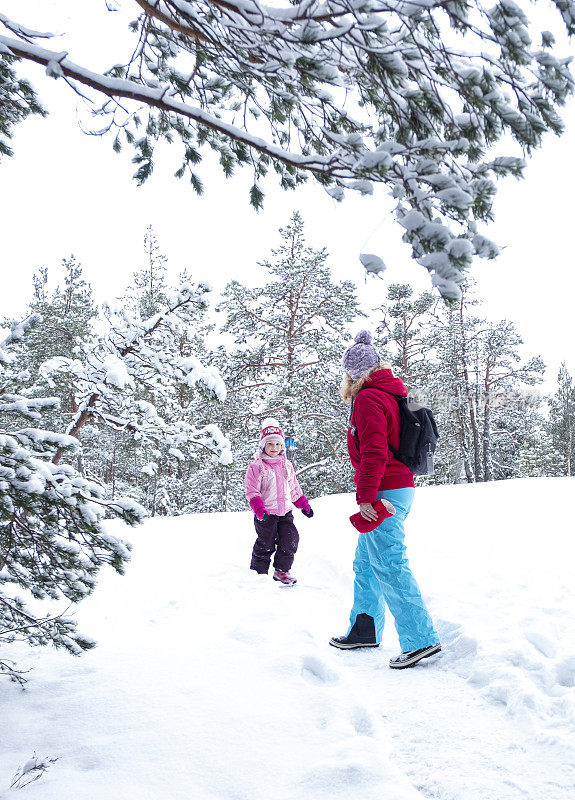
[0,478,575,800]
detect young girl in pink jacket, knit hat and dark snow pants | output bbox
[245,418,313,586]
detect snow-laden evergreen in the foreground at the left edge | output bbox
[0,314,145,682]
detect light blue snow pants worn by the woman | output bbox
[348,488,439,653]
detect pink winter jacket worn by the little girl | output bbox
[245,454,303,517]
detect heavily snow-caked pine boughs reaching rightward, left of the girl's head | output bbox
[40,283,232,464]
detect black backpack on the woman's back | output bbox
[389,394,439,475]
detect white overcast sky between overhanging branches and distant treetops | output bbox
[0,0,575,388]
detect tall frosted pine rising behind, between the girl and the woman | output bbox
[219,213,360,495]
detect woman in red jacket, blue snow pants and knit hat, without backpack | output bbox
[330,331,441,669]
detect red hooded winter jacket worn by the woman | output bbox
[347,369,415,503]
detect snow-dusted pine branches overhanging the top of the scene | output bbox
[0,0,575,299]
